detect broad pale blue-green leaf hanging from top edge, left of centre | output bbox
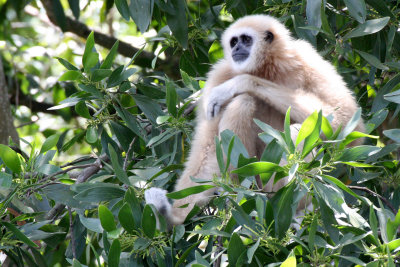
[129,0,154,33]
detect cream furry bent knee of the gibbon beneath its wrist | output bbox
[218,94,259,156]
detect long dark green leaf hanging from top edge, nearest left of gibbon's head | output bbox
[165,0,188,49]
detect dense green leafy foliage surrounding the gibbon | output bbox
[0,0,400,267]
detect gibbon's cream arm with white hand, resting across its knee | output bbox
[203,74,363,131]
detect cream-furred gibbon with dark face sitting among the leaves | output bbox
[145,15,364,225]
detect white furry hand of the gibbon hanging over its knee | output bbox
[206,75,241,120]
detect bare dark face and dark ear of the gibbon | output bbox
[229,31,274,63]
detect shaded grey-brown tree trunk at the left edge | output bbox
[0,57,19,145]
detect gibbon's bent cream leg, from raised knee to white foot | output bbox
[145,94,260,225]
